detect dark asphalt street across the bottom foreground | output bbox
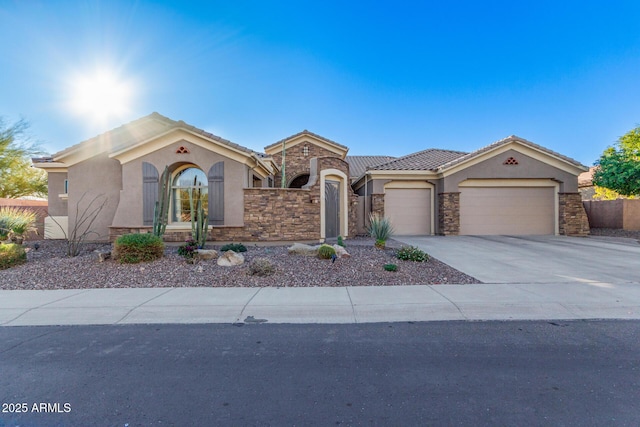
[0,320,640,427]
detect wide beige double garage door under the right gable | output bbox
[460,187,555,235]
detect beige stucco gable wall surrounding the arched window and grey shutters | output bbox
[113,139,249,227]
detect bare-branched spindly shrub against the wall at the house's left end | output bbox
[49,193,109,257]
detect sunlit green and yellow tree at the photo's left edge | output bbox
[0,117,47,199]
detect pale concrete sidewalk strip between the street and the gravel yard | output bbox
[0,281,640,326]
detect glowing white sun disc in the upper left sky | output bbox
[71,70,132,122]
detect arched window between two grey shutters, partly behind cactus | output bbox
[171,167,209,222]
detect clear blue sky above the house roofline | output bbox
[0,0,640,165]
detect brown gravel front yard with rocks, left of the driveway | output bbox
[0,239,480,289]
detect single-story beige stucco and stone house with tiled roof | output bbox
[33,113,588,242]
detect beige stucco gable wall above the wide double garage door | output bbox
[438,150,578,193]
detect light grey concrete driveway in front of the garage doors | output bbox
[394,236,640,284]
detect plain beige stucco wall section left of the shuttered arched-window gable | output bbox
[67,154,122,241]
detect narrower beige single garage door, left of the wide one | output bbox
[384,188,431,236]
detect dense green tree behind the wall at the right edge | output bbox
[593,126,640,196]
